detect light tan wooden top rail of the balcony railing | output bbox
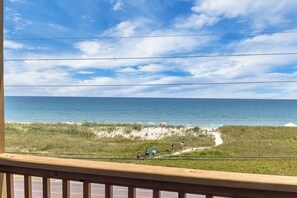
[0,153,297,193]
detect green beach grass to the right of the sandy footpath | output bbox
[136,126,297,176]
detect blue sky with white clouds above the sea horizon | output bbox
[4,0,297,99]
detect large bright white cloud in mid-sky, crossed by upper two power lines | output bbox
[67,20,215,69]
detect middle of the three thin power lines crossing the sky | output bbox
[4,52,297,62]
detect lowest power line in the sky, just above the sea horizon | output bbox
[4,80,297,87]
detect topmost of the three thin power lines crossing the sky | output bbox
[8,31,297,41]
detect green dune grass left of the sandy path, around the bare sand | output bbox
[5,123,214,157]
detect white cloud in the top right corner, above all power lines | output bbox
[176,0,297,30]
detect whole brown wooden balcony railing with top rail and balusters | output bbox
[0,153,297,198]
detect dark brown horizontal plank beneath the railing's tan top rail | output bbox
[0,164,297,198]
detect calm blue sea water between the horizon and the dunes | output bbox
[5,96,297,126]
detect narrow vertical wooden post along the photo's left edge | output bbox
[0,0,6,197]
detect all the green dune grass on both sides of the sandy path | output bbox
[5,123,297,176]
